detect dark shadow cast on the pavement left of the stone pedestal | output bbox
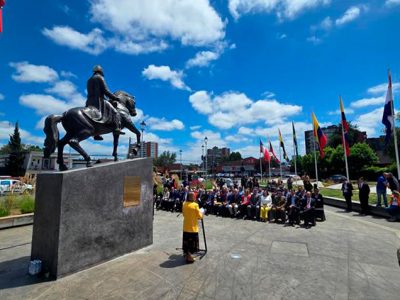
[0,256,48,290]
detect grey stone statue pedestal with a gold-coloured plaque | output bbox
[31,158,153,278]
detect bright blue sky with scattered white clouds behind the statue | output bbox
[0,0,400,162]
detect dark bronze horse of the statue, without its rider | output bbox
[43,91,140,171]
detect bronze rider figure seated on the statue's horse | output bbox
[86,65,125,141]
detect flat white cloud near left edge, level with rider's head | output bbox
[9,61,58,82]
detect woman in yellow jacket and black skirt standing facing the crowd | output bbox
[182,192,203,263]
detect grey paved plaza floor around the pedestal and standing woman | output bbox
[0,206,400,300]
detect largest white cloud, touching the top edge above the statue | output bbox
[42,0,225,55]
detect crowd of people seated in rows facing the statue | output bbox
[155,177,325,228]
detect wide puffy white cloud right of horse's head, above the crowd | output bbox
[189,91,302,129]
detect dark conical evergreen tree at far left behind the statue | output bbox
[6,122,25,176]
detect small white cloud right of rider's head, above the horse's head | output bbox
[142,65,190,91]
